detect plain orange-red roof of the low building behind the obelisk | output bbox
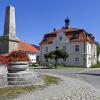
[18,41,39,52]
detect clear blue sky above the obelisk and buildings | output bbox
[0,0,100,45]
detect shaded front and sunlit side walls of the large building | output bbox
[41,33,96,67]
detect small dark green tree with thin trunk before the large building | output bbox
[44,49,68,68]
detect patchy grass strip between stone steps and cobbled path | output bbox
[0,75,61,96]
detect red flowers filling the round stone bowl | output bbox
[8,50,29,62]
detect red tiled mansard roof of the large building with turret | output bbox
[40,28,94,45]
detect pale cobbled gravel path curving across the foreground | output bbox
[13,76,100,100]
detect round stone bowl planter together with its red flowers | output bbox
[7,51,29,73]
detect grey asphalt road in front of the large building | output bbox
[35,69,100,90]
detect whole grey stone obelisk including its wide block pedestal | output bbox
[0,5,20,54]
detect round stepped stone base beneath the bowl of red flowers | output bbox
[7,68,39,85]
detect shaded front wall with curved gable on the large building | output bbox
[41,33,84,66]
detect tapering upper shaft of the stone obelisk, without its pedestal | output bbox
[4,5,16,35]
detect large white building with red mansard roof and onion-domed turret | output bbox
[40,19,97,68]
